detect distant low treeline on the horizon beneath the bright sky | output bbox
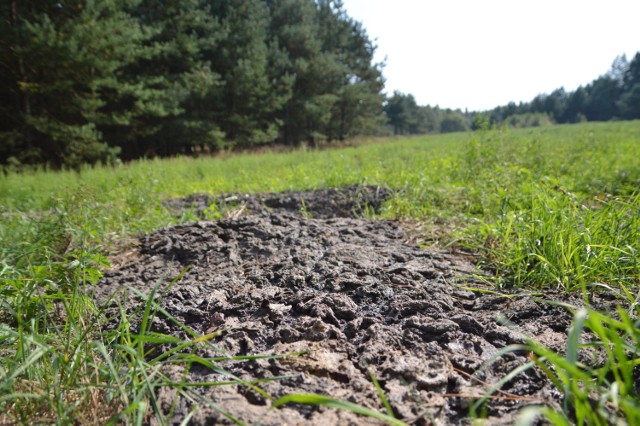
[385,52,640,134]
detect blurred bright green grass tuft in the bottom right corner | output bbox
[471,306,640,425]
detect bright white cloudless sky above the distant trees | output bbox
[343,0,640,111]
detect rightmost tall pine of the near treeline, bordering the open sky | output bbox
[268,0,383,143]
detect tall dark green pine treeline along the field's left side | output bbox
[0,0,384,167]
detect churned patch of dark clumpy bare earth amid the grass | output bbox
[95,186,600,425]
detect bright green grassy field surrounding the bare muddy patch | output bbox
[0,121,640,424]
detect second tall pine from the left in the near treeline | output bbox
[119,0,224,159]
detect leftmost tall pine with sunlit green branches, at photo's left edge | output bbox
[0,0,149,167]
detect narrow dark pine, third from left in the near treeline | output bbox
[210,0,291,146]
